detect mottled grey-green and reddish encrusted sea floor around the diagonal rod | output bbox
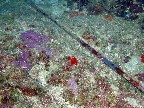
[0,1,144,108]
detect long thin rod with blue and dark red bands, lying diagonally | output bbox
[25,0,144,93]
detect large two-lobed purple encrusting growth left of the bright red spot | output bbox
[15,30,52,70]
